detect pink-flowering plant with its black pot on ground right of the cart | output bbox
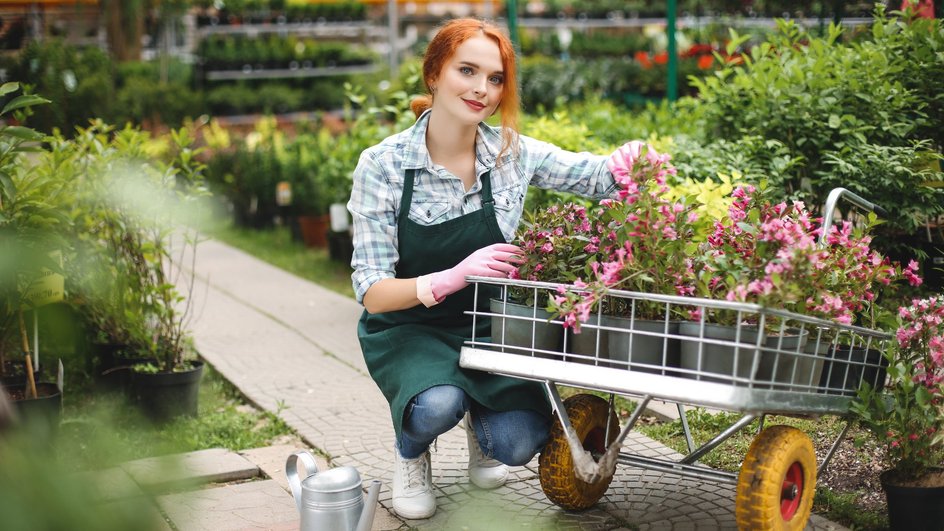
[850,295,944,530]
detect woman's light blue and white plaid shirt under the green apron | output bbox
[347,111,616,302]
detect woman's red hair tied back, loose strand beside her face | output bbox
[410,18,521,159]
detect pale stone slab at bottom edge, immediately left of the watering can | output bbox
[157,479,299,531]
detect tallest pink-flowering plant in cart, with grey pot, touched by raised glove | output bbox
[552,142,697,372]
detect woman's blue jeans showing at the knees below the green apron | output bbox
[397,385,550,466]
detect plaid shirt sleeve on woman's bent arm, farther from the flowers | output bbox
[347,149,400,304]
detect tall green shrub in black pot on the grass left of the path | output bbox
[62,123,206,420]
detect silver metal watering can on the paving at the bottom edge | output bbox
[285,452,380,531]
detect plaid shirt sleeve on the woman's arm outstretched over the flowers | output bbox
[520,135,616,199]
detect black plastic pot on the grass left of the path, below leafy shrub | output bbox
[131,361,203,422]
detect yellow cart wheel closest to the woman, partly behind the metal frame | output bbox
[538,394,619,511]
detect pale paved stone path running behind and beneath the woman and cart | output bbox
[149,241,842,531]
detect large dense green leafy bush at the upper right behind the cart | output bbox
[693,10,944,241]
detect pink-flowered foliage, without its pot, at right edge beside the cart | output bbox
[851,295,944,481]
